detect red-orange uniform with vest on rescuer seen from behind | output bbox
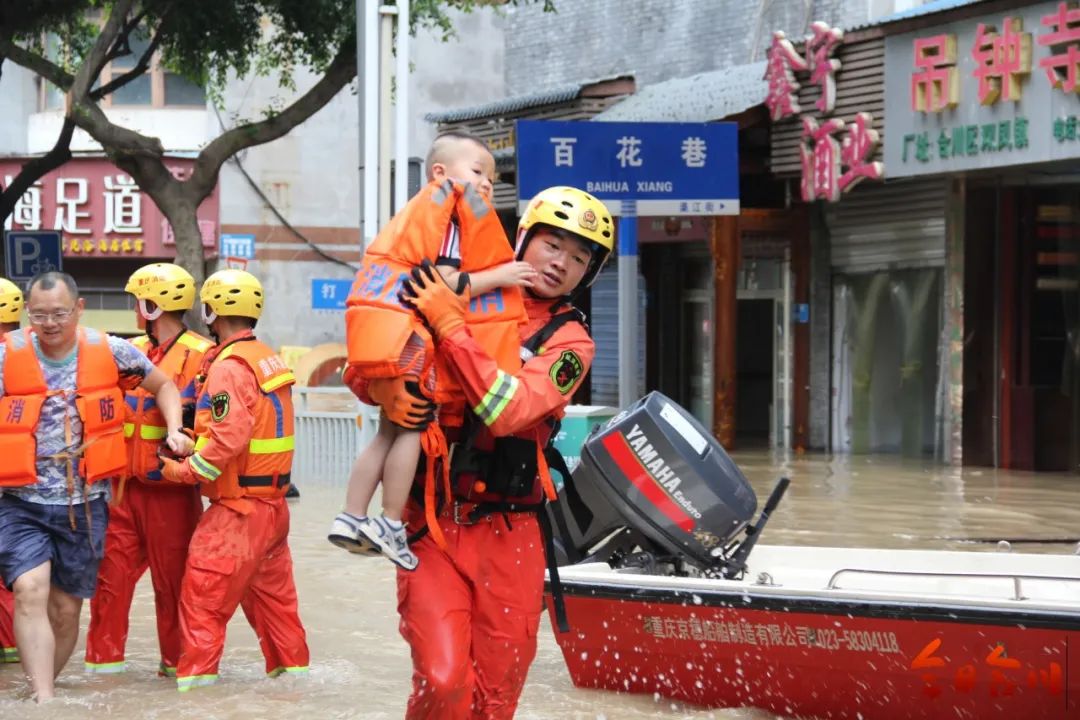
[168,330,309,692]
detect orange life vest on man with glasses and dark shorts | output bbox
[0,327,127,488]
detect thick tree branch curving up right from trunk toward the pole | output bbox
[187,42,356,201]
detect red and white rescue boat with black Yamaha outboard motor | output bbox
[546,393,1080,720]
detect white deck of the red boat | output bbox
[559,545,1080,621]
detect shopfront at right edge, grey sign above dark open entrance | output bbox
[885,2,1080,473]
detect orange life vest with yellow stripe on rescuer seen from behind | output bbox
[191,338,296,500]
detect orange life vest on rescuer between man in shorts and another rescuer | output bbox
[124,329,214,483]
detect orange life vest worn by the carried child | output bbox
[346,180,527,414]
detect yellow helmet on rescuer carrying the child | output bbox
[517,186,615,288]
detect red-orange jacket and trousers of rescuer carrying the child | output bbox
[397,299,595,720]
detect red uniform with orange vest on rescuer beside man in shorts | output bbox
[85,330,214,676]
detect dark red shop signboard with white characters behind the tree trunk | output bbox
[0,158,220,259]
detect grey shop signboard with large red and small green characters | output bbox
[885,2,1080,177]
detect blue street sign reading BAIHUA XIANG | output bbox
[517,120,739,216]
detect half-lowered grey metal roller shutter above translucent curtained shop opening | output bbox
[825,178,946,272]
